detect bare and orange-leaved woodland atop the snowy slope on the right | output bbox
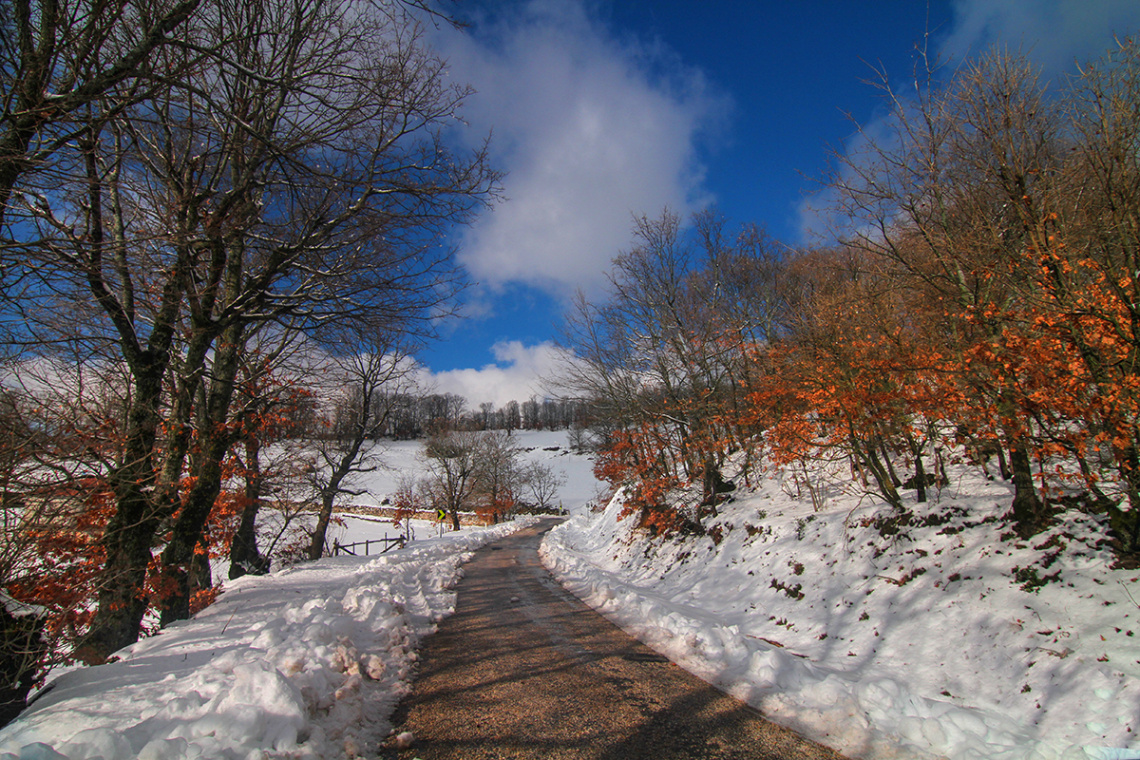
[563,40,1140,562]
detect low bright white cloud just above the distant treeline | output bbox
[423,341,563,409]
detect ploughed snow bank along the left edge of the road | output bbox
[0,521,532,760]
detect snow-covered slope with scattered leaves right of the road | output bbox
[544,473,1140,760]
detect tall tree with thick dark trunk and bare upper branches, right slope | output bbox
[834,48,1064,536]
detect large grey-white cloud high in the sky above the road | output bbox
[430,0,726,295]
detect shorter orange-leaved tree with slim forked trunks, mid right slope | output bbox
[749,248,954,510]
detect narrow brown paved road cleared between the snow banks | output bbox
[383,522,841,760]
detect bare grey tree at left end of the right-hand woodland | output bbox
[561,211,782,513]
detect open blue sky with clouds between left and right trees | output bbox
[418,0,1140,406]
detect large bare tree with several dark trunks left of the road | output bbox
[9,0,495,660]
